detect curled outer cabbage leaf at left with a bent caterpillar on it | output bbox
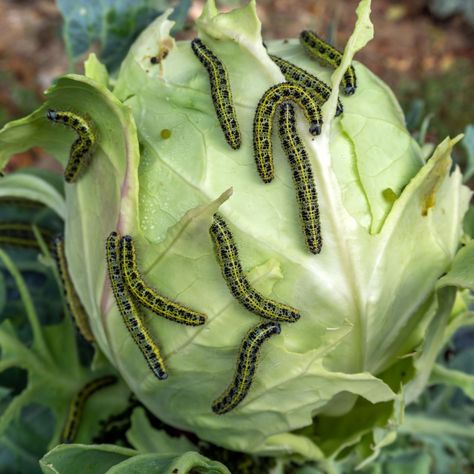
[0,71,143,358]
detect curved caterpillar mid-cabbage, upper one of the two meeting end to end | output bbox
[209,214,300,323]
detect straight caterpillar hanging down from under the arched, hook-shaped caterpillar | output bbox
[279,102,323,254]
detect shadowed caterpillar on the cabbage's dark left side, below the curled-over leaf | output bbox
[52,235,95,342]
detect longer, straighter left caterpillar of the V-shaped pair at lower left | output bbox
[106,232,168,380]
